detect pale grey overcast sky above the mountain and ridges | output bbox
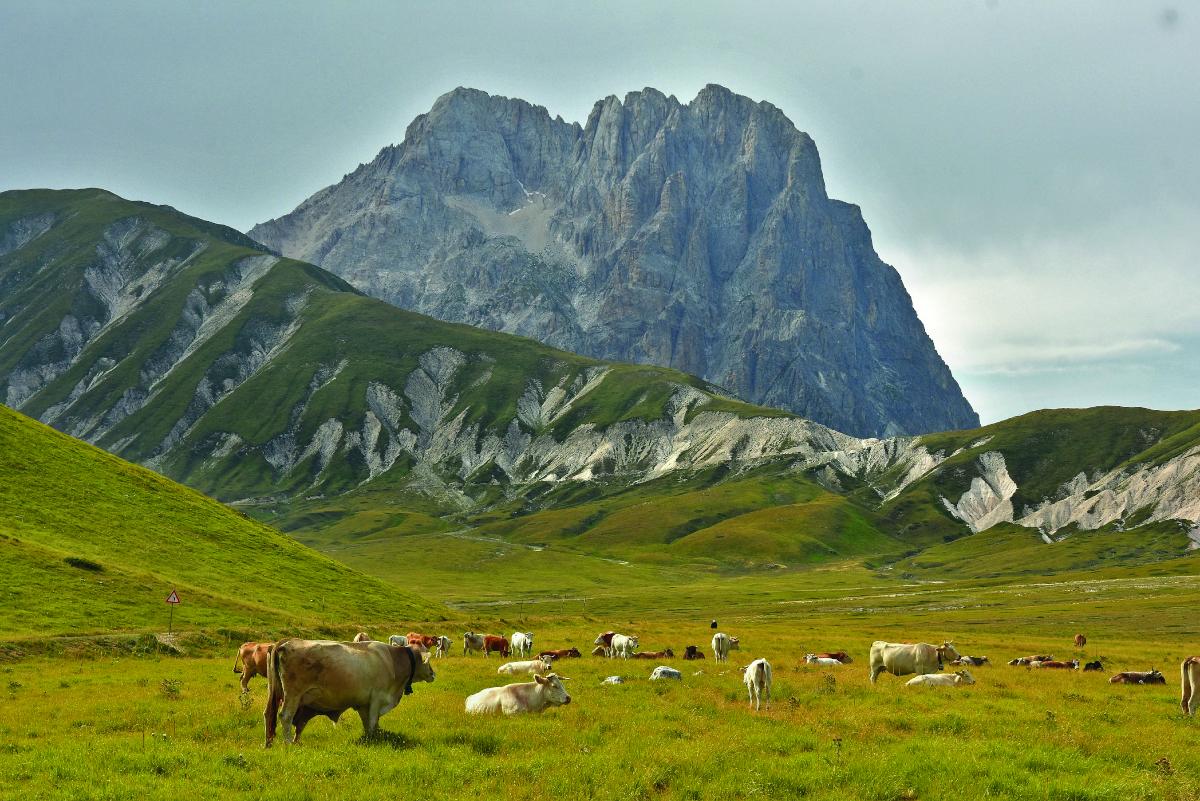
[0,0,1200,422]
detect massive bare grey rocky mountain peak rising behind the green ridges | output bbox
[250,85,979,435]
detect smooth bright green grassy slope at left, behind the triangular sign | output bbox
[0,406,444,637]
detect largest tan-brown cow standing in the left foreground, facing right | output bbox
[263,639,434,747]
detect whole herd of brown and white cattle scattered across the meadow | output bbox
[226,621,1200,747]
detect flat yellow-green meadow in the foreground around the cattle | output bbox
[0,577,1200,801]
